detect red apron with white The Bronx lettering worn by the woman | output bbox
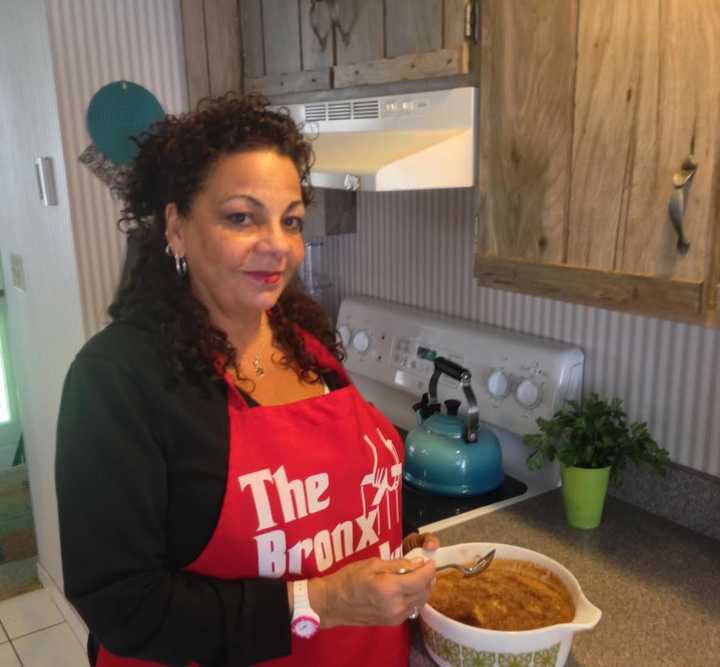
[97,333,409,667]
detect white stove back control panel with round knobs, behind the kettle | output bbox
[337,297,584,434]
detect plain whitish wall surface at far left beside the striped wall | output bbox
[0,0,84,583]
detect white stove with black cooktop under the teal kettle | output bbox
[337,297,584,532]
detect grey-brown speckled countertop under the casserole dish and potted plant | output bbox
[410,489,720,667]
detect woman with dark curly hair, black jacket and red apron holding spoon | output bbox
[57,97,437,667]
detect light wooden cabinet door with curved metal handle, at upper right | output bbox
[567,0,720,282]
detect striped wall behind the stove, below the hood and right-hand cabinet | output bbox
[323,189,720,476]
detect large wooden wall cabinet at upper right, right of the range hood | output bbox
[475,0,720,322]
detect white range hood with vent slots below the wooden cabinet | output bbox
[287,88,477,192]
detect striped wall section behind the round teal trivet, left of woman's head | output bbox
[47,0,186,336]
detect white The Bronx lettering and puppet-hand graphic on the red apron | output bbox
[238,428,402,577]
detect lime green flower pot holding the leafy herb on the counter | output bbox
[560,465,610,528]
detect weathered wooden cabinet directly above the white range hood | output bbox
[182,0,479,104]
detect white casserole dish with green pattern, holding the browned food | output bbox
[407,542,602,667]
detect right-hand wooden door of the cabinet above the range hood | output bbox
[334,0,478,88]
